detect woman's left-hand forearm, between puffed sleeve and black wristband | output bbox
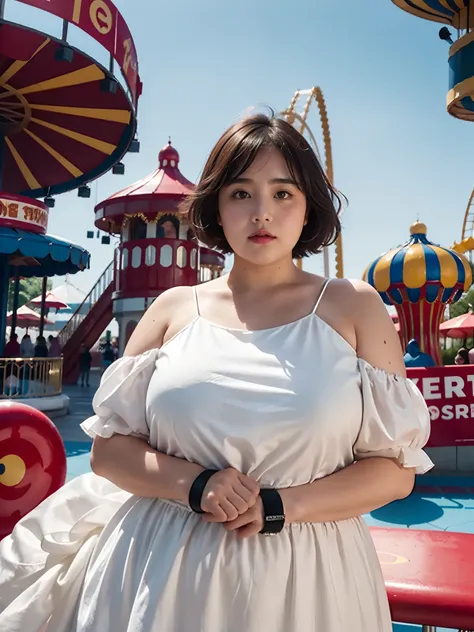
[91,434,204,502]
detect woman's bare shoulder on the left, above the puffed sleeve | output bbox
[125,286,194,355]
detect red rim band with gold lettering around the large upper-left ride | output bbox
[13,0,140,105]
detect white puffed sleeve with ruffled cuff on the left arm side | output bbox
[81,349,159,439]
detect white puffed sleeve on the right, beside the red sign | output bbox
[354,360,433,474]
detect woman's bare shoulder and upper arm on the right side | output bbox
[321,279,406,376]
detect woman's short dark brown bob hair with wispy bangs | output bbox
[182,114,342,259]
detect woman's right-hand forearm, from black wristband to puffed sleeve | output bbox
[279,457,415,522]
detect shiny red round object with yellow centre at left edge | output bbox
[0,401,66,540]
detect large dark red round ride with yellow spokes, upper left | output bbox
[0,0,141,197]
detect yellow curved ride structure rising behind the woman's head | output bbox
[281,87,344,278]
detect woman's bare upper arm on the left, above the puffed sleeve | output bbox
[125,287,191,356]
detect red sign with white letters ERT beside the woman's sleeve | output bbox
[407,365,474,447]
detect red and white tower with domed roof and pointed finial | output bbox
[95,141,225,353]
